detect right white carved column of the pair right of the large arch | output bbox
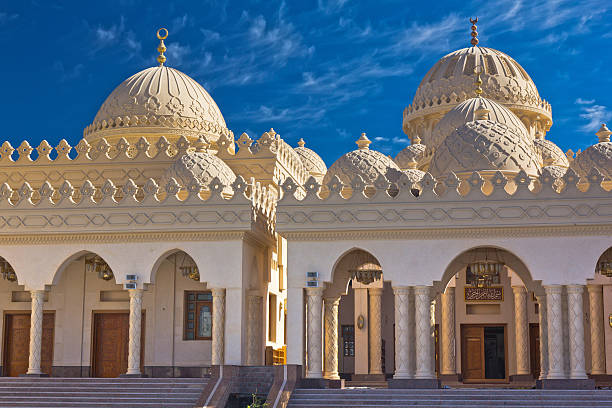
[567,285,587,379]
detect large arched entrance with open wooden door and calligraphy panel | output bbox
[436,247,541,383]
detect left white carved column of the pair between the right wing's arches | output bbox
[393,286,414,379]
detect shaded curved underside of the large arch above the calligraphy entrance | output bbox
[434,245,543,294]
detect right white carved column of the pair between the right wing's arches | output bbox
[414,286,434,378]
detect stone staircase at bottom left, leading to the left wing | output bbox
[0,377,208,408]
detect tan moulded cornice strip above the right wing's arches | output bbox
[279,224,612,241]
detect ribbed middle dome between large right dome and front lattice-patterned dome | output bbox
[427,98,527,150]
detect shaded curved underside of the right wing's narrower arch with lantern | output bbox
[325,247,383,297]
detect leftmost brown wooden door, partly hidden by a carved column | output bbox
[3,312,55,377]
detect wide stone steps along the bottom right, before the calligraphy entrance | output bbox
[288,388,612,408]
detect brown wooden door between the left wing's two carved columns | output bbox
[92,311,146,378]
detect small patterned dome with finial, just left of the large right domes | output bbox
[323,133,399,184]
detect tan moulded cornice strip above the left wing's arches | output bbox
[0,231,250,245]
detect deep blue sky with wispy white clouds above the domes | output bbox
[0,0,612,165]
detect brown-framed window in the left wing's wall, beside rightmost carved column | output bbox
[183,291,212,340]
